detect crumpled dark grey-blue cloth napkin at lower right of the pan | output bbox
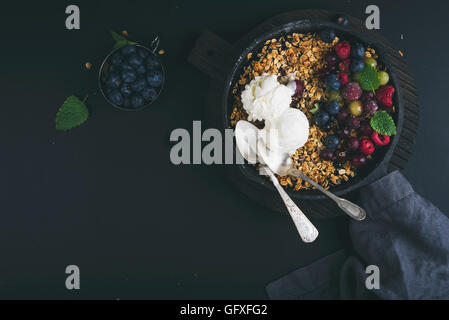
[267,171,449,300]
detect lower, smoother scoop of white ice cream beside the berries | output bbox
[261,108,309,155]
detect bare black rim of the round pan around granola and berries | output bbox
[222,20,403,200]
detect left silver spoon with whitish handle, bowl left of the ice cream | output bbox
[235,121,319,243]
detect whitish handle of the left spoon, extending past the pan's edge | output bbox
[263,167,318,243]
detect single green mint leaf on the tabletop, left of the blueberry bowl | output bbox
[56,96,89,131]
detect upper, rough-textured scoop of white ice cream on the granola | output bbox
[242,75,295,121]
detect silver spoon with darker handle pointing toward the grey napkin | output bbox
[265,149,366,221]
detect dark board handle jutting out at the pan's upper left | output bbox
[188,31,236,83]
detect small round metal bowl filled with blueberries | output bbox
[99,37,165,111]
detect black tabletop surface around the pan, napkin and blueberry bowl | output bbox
[0,0,449,299]
